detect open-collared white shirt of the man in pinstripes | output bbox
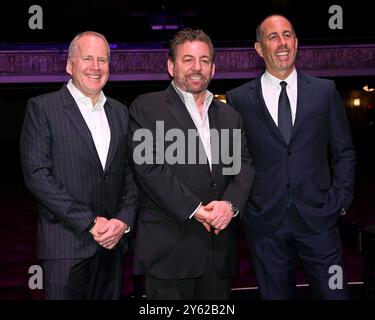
[67,79,111,170]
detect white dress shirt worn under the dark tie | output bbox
[260,69,297,126]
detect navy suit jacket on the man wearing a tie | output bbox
[227,72,355,238]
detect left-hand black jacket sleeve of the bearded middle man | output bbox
[128,99,201,224]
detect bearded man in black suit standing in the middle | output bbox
[129,29,253,299]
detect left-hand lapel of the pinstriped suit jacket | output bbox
[61,86,102,167]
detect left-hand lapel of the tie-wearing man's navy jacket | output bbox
[249,77,285,144]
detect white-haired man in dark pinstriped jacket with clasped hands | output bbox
[20,32,137,299]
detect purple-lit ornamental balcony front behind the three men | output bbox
[0,44,375,83]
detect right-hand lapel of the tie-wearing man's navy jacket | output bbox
[290,72,312,142]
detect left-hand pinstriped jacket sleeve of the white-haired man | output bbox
[20,99,95,234]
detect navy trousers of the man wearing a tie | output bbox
[246,205,348,299]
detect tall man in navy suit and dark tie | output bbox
[227,15,355,299]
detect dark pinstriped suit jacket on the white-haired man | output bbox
[20,86,137,259]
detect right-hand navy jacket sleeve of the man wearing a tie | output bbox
[329,82,356,210]
